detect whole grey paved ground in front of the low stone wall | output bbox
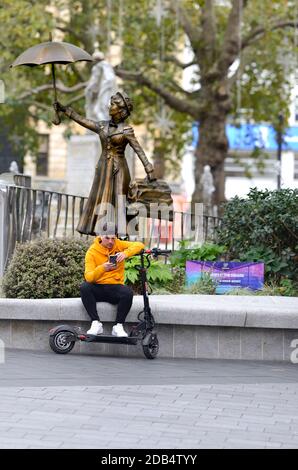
[0,350,298,449]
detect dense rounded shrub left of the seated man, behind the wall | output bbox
[2,238,90,299]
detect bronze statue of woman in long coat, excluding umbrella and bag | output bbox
[54,92,155,235]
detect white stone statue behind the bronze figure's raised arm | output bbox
[85,51,117,121]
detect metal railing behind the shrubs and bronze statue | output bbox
[0,185,221,270]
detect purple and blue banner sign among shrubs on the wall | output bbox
[186,261,264,294]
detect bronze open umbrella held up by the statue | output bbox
[10,41,93,124]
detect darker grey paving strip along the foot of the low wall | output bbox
[0,349,298,388]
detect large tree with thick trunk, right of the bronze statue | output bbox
[117,0,298,204]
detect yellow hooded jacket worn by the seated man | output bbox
[85,237,145,284]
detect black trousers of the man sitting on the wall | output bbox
[80,282,133,323]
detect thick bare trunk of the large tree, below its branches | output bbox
[192,108,228,206]
